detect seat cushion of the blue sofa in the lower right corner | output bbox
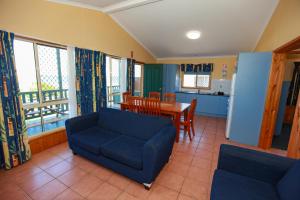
[211,169,279,200]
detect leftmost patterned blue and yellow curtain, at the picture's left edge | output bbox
[0,31,31,169]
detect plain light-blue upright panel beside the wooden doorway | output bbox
[229,52,272,146]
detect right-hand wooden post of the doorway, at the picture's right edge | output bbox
[287,93,300,159]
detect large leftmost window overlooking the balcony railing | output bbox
[14,39,69,136]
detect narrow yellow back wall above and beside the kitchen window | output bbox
[157,56,236,80]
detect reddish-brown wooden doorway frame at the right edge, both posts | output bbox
[259,36,300,158]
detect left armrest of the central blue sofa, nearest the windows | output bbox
[65,112,99,136]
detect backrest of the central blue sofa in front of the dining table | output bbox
[98,109,171,141]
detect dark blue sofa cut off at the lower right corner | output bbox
[211,145,300,200]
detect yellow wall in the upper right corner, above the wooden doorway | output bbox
[255,0,300,51]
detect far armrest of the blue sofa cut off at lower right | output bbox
[218,144,295,184]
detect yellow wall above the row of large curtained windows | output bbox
[0,0,155,62]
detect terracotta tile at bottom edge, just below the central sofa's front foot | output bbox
[148,185,179,200]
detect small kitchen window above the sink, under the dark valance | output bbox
[182,74,210,89]
